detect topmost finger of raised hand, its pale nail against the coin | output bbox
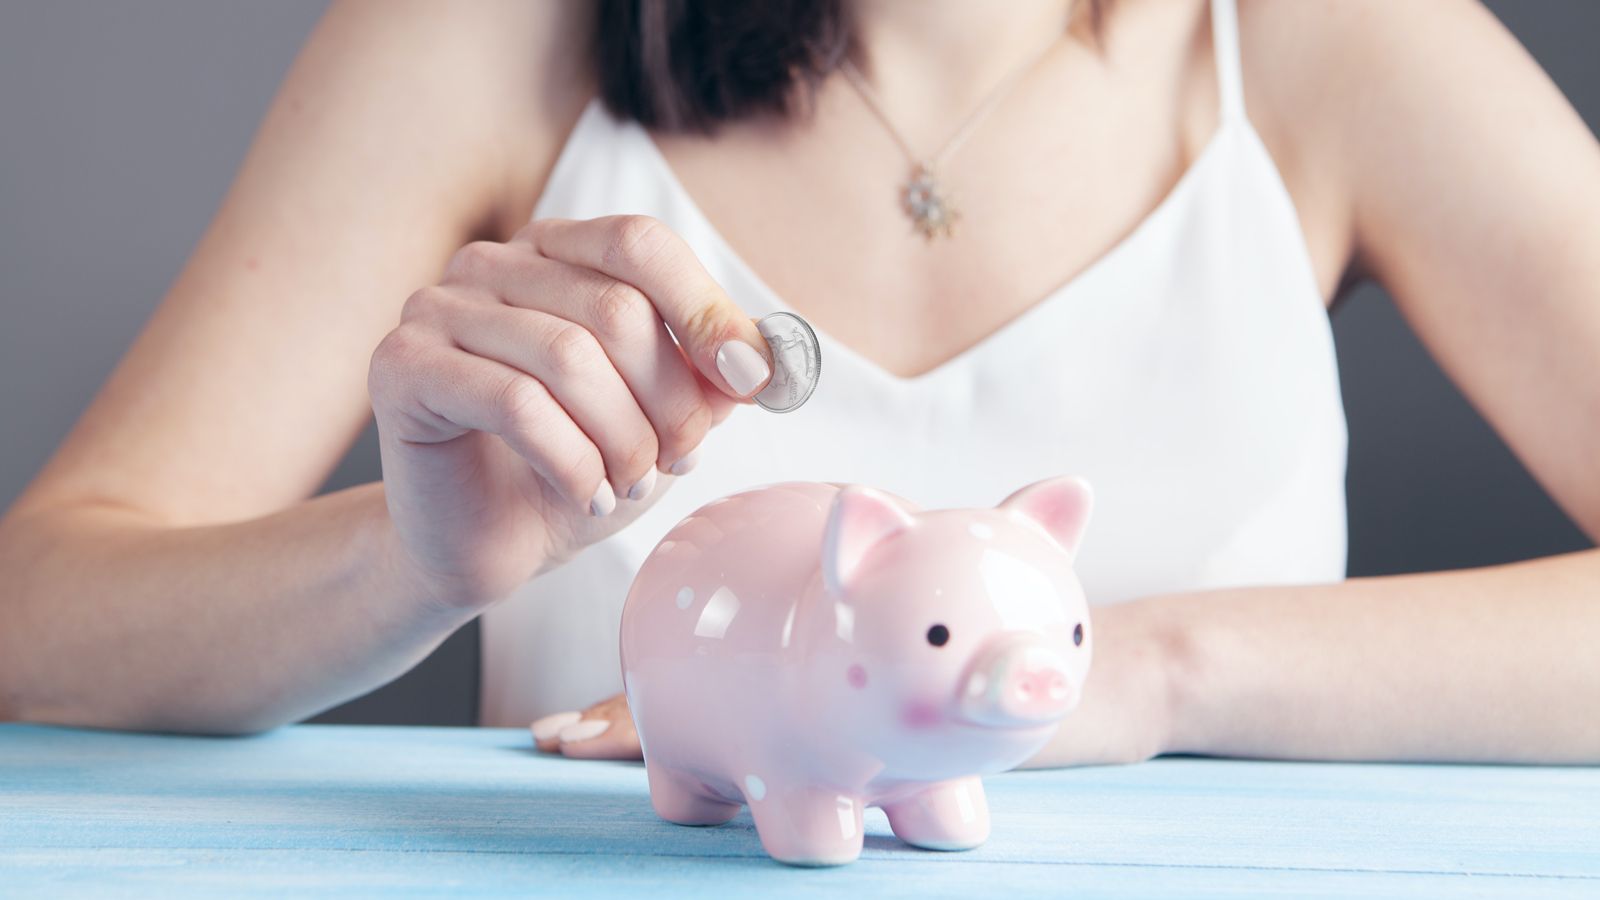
[520,216,771,399]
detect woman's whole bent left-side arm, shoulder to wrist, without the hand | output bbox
[0,2,589,730]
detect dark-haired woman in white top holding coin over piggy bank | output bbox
[0,0,1600,765]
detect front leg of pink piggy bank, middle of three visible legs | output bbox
[746,785,862,866]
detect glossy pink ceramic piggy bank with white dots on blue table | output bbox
[621,477,1093,865]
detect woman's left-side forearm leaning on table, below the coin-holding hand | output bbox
[0,484,472,732]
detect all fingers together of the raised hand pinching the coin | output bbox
[380,216,748,516]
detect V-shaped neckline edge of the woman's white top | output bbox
[624,101,1240,389]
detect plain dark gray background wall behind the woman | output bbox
[0,0,1600,724]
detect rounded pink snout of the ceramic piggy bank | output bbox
[960,641,1078,727]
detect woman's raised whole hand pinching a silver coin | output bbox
[368,216,770,609]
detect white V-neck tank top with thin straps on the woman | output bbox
[482,0,1346,725]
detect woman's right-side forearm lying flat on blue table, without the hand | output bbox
[1147,551,1600,764]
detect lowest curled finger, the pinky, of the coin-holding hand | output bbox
[370,325,616,514]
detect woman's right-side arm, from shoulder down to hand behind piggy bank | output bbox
[1035,0,1600,765]
